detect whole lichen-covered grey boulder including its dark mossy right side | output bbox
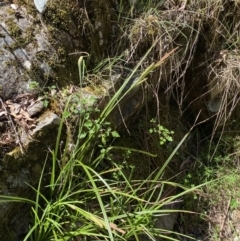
[0,3,81,99]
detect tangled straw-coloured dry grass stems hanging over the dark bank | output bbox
[123,0,240,131]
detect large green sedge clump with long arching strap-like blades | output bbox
[0,43,206,241]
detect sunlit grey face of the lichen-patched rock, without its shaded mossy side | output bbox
[0,4,46,98]
